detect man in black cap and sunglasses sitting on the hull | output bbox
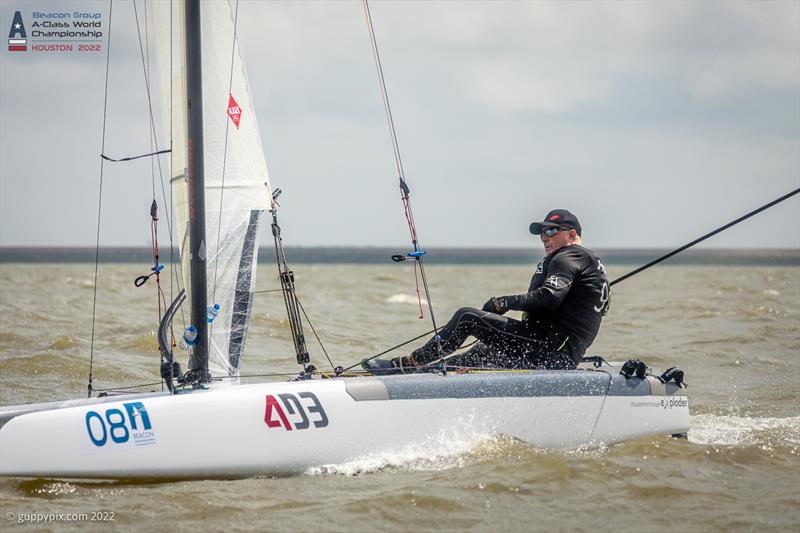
[362,209,610,373]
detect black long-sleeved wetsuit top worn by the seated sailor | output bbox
[505,244,611,356]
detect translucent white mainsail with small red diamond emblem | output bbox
[151,1,272,377]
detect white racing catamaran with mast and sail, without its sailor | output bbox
[0,0,689,479]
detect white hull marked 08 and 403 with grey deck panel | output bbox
[0,370,689,479]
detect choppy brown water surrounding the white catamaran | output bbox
[0,263,800,531]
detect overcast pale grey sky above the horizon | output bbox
[0,0,800,251]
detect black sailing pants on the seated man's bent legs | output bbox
[412,307,576,369]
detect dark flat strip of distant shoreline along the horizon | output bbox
[0,246,800,266]
